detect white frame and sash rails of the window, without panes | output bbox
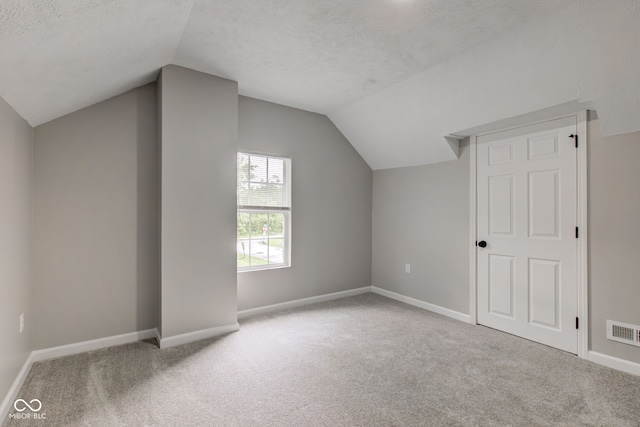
[236,150,291,273]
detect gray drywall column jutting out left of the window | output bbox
[158,65,238,347]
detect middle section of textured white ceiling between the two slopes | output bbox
[174,0,558,114]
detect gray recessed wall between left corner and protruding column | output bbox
[32,85,158,349]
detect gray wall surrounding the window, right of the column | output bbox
[238,97,372,310]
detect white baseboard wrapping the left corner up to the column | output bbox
[0,328,159,423]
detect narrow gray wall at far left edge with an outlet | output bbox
[0,98,34,402]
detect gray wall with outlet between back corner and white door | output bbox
[372,142,469,314]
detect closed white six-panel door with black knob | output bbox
[476,117,578,353]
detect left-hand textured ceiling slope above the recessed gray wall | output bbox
[0,0,192,126]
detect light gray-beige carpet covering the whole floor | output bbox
[4,294,640,426]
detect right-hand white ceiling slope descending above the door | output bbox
[329,0,640,169]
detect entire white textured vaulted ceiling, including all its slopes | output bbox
[0,0,640,169]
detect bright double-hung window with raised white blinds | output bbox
[236,152,291,271]
